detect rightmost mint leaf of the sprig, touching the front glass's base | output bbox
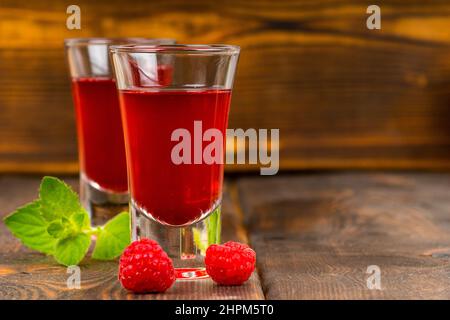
[92,212,130,260]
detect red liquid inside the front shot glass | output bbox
[120,90,231,226]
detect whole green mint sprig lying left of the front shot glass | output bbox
[4,177,130,266]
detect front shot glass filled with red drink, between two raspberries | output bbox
[111,45,239,279]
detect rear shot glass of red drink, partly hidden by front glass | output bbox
[65,38,175,224]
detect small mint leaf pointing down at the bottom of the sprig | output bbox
[54,233,91,266]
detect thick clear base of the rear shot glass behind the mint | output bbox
[80,174,129,226]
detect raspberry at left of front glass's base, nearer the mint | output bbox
[119,239,175,293]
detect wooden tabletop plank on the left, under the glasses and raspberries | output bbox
[0,176,264,300]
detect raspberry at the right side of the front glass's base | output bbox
[205,241,256,286]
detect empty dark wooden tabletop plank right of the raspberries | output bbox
[234,174,450,299]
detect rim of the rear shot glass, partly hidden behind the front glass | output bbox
[64,37,176,47]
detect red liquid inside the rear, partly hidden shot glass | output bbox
[72,78,128,192]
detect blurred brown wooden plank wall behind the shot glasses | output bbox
[0,0,450,172]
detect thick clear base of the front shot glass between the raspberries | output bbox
[131,201,221,280]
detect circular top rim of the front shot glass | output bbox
[109,43,241,55]
